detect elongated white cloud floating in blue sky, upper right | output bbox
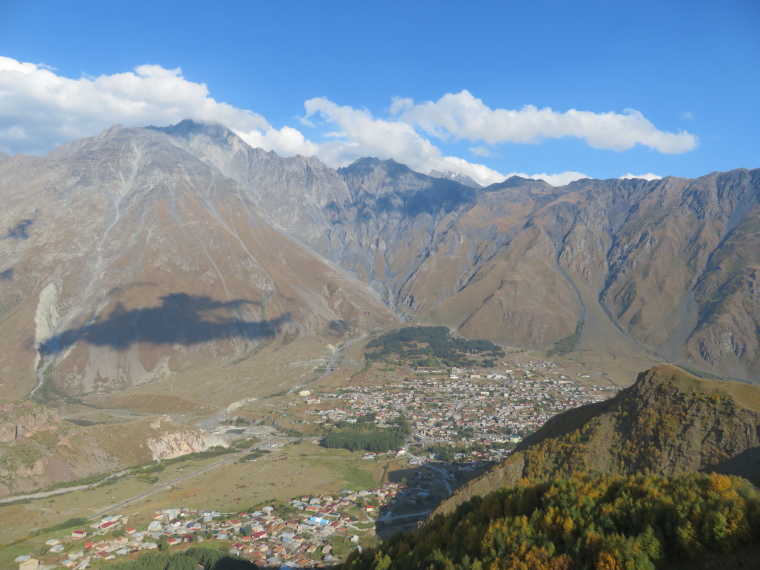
[391,90,697,154]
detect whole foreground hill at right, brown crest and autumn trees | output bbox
[344,365,760,570]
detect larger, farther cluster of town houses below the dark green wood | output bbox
[304,362,615,459]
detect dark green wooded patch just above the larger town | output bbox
[366,326,504,367]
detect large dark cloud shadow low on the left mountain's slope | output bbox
[38,293,292,355]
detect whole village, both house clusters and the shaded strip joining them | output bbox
[15,361,619,570]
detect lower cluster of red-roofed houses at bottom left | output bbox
[16,483,404,570]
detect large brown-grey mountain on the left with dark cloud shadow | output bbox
[0,122,396,403]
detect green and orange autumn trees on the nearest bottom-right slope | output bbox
[343,473,760,570]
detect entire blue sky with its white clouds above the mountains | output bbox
[0,0,760,184]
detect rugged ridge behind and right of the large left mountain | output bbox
[163,121,760,378]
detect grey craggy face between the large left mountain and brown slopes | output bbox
[157,121,475,312]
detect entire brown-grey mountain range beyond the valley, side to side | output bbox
[0,121,760,405]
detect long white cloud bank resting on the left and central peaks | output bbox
[0,56,501,183]
